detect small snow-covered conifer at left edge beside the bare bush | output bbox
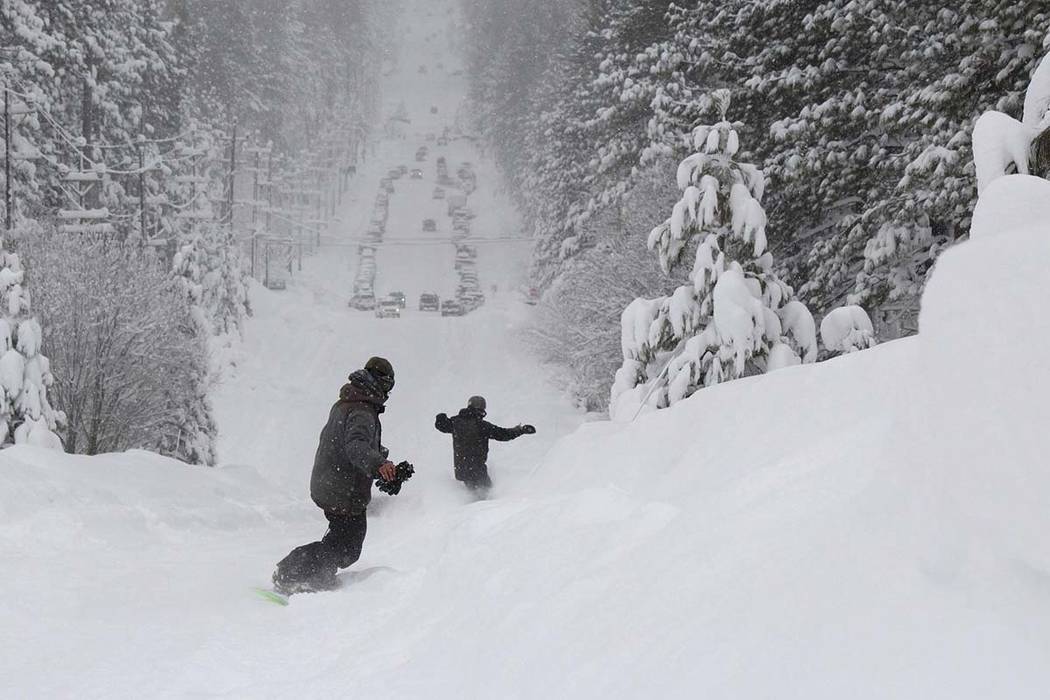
[0,230,62,449]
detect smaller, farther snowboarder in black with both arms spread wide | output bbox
[434,397,536,496]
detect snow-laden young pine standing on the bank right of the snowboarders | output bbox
[610,90,817,416]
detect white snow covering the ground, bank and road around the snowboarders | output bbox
[0,0,1050,700]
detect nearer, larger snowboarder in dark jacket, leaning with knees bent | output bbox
[273,357,396,594]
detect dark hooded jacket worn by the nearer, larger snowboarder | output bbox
[310,373,386,513]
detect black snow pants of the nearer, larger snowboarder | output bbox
[277,510,368,584]
